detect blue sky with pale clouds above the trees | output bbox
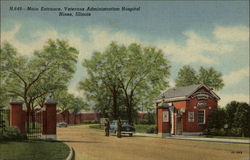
[0,0,249,106]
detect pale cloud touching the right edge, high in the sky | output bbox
[213,26,249,41]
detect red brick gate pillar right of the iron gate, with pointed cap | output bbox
[42,98,57,139]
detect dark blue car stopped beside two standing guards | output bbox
[110,120,135,137]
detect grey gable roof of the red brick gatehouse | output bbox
[158,84,220,101]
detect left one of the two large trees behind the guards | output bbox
[80,50,120,119]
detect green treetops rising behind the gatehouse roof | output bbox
[175,65,224,90]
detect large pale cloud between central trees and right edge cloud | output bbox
[161,31,233,64]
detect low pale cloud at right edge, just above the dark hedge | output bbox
[223,66,249,86]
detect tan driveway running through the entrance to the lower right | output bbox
[57,125,249,160]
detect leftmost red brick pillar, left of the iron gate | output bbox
[10,101,25,134]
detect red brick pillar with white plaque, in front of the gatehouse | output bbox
[157,107,171,137]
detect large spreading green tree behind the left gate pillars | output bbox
[1,40,78,128]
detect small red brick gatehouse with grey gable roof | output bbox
[156,84,220,136]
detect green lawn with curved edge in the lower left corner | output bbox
[0,140,69,160]
